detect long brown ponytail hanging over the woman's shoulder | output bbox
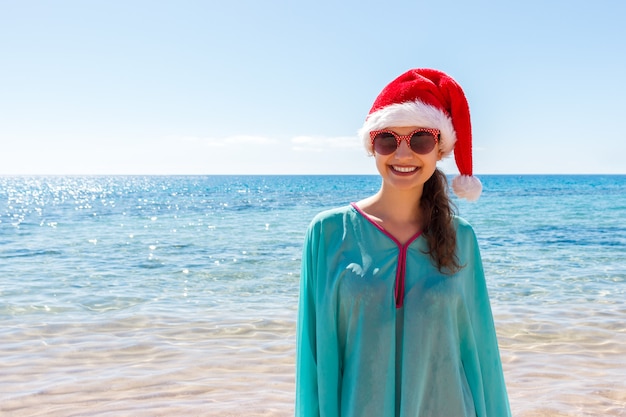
[420,169,463,275]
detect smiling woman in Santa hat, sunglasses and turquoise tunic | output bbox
[296,69,510,417]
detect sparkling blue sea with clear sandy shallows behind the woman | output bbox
[0,175,626,417]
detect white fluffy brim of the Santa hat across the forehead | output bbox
[359,99,456,157]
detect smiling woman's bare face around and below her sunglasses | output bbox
[374,126,441,190]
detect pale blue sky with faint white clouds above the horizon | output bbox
[0,0,626,175]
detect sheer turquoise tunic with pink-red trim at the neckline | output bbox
[295,205,511,417]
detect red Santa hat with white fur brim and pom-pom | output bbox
[359,68,482,201]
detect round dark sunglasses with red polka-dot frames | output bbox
[370,128,439,155]
